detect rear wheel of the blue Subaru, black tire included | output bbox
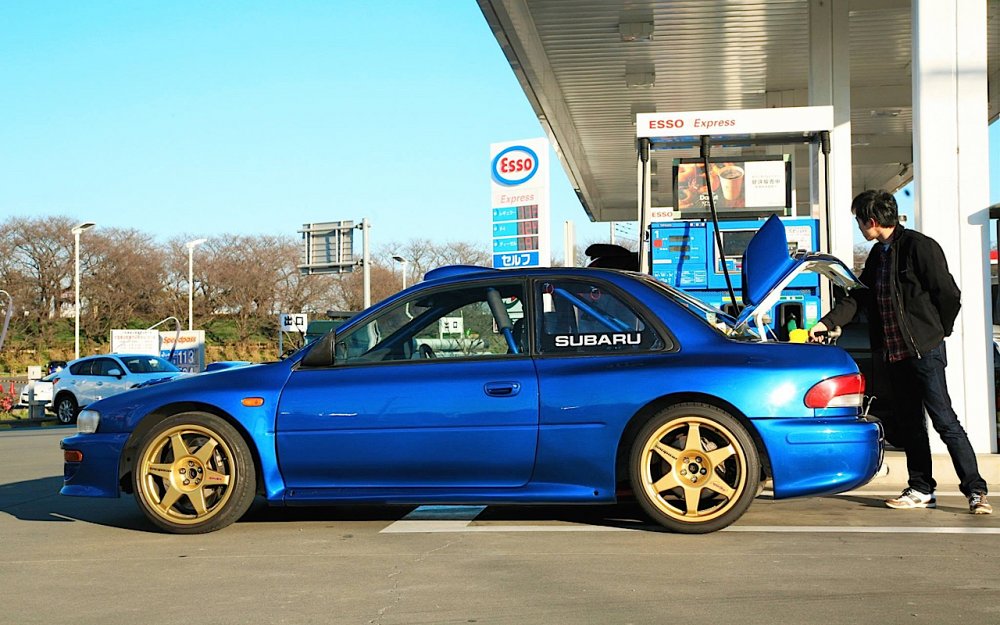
[629,403,760,534]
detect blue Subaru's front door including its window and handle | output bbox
[276,281,538,488]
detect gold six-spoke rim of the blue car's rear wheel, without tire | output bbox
[640,415,747,523]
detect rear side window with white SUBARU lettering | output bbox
[535,279,664,354]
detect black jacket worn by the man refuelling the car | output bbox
[821,225,962,358]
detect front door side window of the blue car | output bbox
[335,282,527,365]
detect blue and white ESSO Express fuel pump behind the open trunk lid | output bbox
[636,106,833,341]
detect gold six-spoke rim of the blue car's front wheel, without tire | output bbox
[137,424,238,525]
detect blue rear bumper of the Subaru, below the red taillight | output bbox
[754,417,884,499]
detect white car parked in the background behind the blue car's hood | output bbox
[52,354,183,423]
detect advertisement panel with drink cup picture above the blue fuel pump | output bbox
[674,156,792,217]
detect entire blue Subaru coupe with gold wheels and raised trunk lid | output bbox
[60,221,882,534]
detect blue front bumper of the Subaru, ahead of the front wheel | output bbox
[59,433,129,497]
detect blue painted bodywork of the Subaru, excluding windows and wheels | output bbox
[61,269,881,516]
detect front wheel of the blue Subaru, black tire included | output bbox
[132,412,257,534]
